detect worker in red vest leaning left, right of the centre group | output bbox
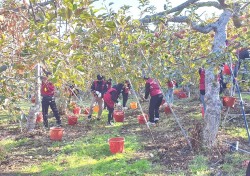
[144,76,163,125]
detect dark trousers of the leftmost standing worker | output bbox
[42,96,61,127]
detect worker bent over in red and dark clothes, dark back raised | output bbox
[103,83,124,125]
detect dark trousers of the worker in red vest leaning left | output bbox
[149,94,163,122]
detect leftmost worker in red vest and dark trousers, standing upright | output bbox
[41,71,61,129]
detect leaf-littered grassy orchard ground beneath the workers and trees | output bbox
[0,96,250,176]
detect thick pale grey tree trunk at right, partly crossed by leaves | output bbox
[203,10,232,148]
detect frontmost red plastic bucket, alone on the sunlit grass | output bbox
[109,137,125,154]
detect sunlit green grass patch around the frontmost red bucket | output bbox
[23,124,151,176]
